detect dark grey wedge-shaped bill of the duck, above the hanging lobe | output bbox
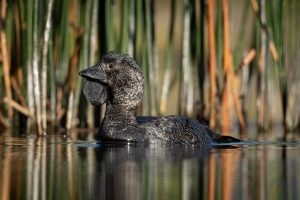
[79,65,107,84]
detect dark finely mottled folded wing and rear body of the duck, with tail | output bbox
[137,116,240,146]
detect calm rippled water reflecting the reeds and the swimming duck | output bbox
[0,135,300,200]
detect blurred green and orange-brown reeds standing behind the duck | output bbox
[0,0,300,136]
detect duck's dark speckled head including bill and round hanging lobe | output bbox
[79,52,144,108]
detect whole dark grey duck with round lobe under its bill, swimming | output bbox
[79,52,239,146]
